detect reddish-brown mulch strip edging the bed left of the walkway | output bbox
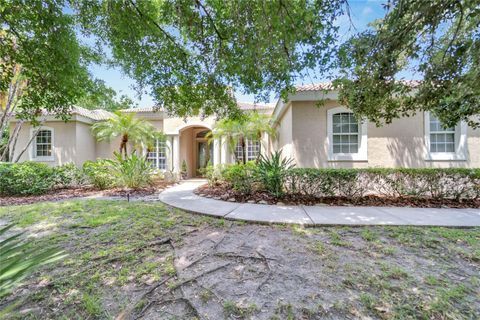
[0,181,171,207]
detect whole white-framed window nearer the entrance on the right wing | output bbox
[327,107,367,161]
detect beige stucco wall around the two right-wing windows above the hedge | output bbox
[292,101,480,168]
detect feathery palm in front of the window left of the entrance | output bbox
[92,111,155,158]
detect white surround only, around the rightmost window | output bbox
[424,111,467,161]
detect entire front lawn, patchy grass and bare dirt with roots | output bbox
[0,200,480,319]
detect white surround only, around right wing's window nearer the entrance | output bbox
[327,107,368,161]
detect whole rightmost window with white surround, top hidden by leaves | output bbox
[424,112,467,160]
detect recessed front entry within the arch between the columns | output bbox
[179,125,214,178]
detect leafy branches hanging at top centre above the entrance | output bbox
[72,0,344,117]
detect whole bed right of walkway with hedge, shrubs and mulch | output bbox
[196,156,480,208]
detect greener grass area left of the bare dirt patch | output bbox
[0,200,216,319]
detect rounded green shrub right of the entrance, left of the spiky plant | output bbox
[221,161,256,194]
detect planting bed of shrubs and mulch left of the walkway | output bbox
[0,154,173,206]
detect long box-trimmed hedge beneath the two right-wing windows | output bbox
[285,168,480,200]
